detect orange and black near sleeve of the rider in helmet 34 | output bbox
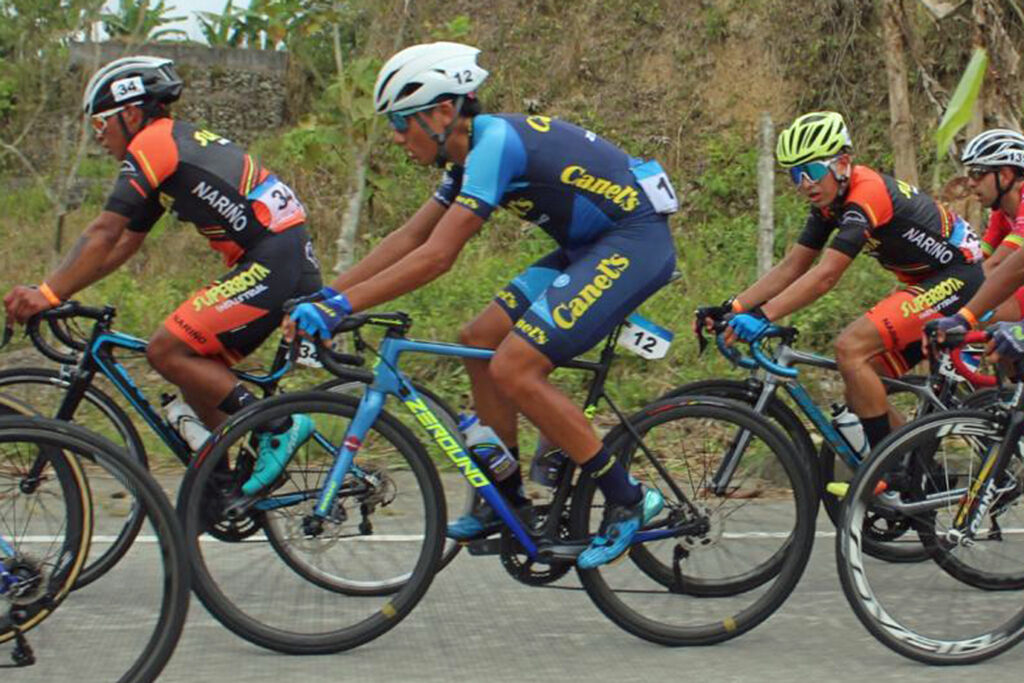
[103,119,178,232]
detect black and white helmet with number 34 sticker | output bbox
[82,56,184,116]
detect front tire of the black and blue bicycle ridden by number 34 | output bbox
[0,368,148,590]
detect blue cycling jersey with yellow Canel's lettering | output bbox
[434,114,674,247]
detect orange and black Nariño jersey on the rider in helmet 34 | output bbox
[105,118,305,264]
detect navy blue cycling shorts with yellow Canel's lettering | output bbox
[495,217,676,365]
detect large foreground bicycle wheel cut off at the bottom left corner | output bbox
[0,417,188,681]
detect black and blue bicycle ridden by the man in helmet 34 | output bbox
[0,301,464,588]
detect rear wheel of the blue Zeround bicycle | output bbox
[570,396,817,645]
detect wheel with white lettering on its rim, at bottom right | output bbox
[836,411,1024,665]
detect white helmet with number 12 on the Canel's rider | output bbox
[374,42,487,114]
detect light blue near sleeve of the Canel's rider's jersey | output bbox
[455,117,526,218]
